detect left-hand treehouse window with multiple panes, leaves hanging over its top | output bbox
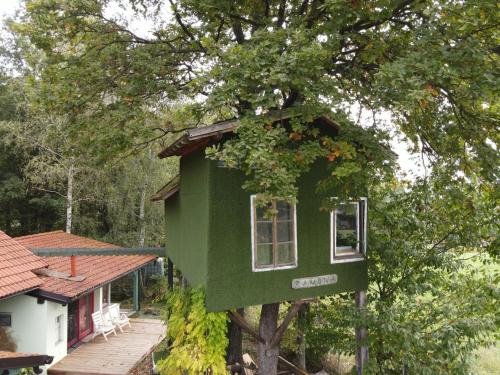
[251,195,297,271]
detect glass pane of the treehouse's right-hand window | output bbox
[335,203,358,255]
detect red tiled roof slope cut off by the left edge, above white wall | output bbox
[0,231,47,298]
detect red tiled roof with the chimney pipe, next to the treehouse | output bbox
[16,231,156,299]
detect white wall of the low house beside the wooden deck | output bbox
[0,295,68,374]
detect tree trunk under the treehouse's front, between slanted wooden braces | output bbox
[257,303,280,375]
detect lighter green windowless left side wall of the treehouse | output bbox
[165,151,210,287]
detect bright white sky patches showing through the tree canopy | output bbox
[0,0,424,177]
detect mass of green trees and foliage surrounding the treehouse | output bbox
[0,0,500,375]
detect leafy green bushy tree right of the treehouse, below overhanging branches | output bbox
[307,172,500,374]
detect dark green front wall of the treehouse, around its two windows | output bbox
[207,162,368,311]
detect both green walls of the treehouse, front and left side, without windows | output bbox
[160,117,368,311]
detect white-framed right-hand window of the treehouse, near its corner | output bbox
[331,198,367,263]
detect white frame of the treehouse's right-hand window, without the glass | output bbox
[330,197,368,264]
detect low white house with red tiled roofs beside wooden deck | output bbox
[0,231,156,374]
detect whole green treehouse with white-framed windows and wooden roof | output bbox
[152,115,368,311]
